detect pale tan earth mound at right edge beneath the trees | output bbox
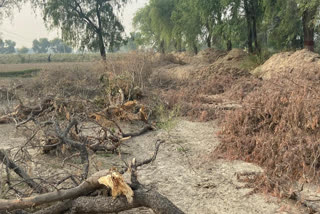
[253,49,320,79]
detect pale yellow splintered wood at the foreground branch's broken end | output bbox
[98,172,134,203]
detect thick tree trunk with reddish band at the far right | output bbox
[302,9,316,51]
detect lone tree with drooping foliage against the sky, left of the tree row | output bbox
[33,0,127,60]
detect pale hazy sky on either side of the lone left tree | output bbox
[0,0,148,48]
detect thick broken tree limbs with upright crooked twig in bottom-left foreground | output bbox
[0,141,183,214]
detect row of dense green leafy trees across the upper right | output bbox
[134,0,320,54]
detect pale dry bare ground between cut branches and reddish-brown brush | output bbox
[119,120,306,214]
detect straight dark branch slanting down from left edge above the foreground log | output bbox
[0,149,48,193]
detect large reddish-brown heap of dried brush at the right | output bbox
[215,71,320,195]
